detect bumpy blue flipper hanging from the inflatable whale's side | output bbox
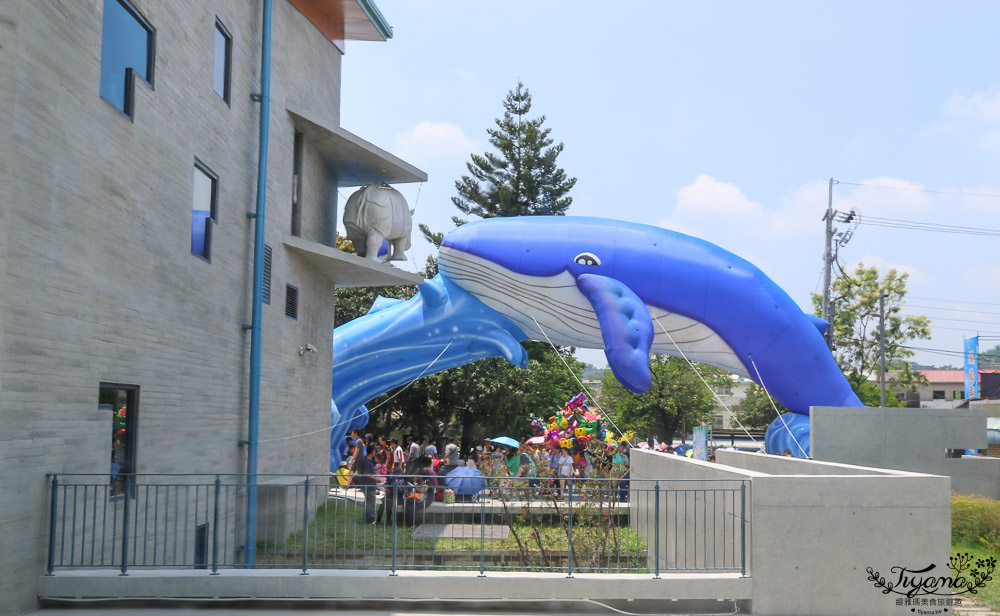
[576,274,653,393]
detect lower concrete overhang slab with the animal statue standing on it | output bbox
[281,235,424,287]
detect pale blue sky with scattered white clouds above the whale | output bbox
[341,0,1000,365]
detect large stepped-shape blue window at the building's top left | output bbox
[101,0,155,118]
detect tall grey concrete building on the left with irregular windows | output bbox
[0,0,426,613]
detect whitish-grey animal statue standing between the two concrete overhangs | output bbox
[344,184,413,261]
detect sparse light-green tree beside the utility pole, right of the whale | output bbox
[812,263,931,406]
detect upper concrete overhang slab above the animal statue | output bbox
[287,108,427,187]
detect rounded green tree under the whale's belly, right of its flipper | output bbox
[601,355,729,443]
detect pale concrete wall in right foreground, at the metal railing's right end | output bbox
[631,450,951,615]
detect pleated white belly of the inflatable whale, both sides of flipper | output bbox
[438,246,749,376]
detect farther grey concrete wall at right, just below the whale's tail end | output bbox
[810,407,1000,498]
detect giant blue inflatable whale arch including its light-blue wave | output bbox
[334,216,862,455]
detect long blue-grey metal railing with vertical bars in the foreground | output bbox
[47,474,749,577]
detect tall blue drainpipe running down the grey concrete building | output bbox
[246,0,273,568]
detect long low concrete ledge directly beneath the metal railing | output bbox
[38,569,752,602]
